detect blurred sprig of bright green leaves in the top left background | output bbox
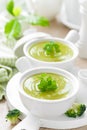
[4,0,49,40]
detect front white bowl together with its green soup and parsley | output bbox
[18,67,79,119]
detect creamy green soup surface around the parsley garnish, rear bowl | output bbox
[28,41,73,62]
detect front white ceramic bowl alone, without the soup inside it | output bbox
[18,67,79,119]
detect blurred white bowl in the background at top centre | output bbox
[25,0,63,20]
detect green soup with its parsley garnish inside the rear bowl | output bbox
[28,41,73,62]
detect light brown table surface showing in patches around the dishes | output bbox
[0,20,87,130]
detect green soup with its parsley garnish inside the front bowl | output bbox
[23,73,72,100]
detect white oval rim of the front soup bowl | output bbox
[18,67,79,103]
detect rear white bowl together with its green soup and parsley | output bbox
[23,37,78,70]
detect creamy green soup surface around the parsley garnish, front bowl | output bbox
[23,73,72,100]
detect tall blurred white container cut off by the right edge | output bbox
[76,0,87,59]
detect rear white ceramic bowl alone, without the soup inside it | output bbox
[23,37,78,70]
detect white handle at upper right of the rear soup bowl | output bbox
[65,30,80,43]
